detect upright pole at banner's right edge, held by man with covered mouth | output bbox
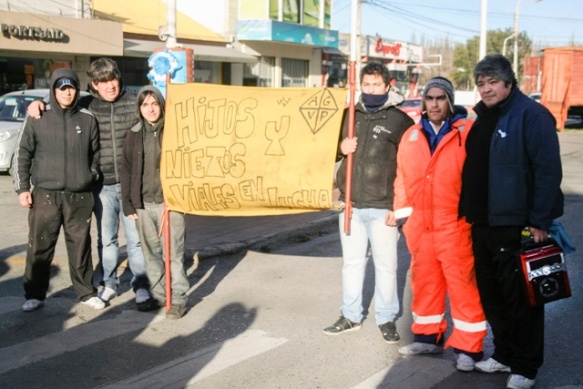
[344,0,360,234]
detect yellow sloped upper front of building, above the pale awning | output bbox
[93,0,227,43]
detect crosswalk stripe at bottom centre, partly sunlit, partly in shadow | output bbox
[103,330,288,389]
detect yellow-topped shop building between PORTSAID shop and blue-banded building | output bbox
[93,0,257,86]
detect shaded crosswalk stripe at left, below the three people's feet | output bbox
[0,308,164,374]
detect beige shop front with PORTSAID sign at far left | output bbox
[0,4,123,94]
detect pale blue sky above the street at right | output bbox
[332,0,583,48]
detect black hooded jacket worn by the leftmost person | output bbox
[14,69,99,194]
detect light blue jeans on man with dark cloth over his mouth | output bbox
[339,208,399,325]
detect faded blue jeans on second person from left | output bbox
[95,184,149,290]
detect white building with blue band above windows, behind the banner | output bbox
[178,0,338,87]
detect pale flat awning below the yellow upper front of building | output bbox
[123,39,257,63]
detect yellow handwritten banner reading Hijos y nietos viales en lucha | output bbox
[161,83,346,216]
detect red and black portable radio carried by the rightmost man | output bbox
[520,239,571,307]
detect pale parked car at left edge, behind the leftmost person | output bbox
[0,89,87,172]
